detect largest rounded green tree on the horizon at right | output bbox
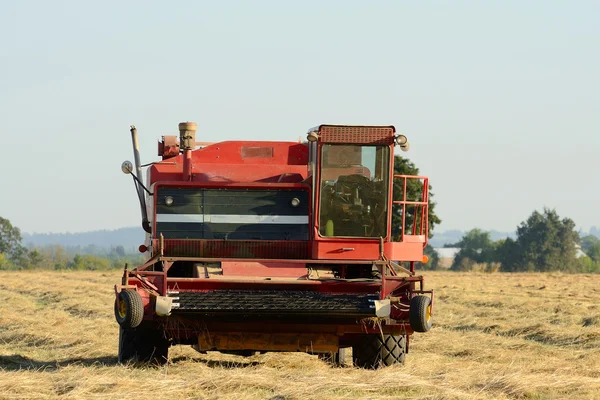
[500,208,579,271]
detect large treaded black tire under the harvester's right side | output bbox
[352,334,406,369]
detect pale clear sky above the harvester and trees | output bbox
[0,0,600,232]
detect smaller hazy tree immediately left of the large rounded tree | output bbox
[449,228,497,271]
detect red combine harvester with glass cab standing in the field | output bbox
[115,122,433,368]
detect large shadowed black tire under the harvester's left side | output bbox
[118,327,169,365]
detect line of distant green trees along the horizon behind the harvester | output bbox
[0,208,600,272]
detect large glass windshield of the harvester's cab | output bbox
[319,144,390,238]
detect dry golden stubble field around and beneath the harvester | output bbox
[0,271,600,400]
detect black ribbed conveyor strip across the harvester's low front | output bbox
[169,290,379,317]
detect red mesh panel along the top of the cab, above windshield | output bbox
[319,125,396,145]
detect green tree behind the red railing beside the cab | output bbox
[392,156,442,239]
